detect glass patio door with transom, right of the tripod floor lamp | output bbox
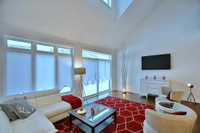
[82,50,112,96]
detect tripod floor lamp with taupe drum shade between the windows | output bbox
[74,68,87,103]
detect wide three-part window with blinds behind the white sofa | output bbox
[4,37,72,95]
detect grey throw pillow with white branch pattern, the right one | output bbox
[10,97,36,119]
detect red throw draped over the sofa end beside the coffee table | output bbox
[62,95,82,109]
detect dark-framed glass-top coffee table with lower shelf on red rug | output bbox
[69,103,117,133]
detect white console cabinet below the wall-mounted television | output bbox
[140,79,169,97]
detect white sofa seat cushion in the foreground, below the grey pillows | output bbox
[11,111,55,133]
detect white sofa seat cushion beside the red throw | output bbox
[38,101,72,118]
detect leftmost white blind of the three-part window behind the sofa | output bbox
[5,52,32,95]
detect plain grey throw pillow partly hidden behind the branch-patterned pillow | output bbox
[0,98,19,121]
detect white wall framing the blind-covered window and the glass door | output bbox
[0,22,116,96]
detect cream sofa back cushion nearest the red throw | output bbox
[35,93,61,108]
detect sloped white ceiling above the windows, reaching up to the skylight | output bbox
[0,0,161,50]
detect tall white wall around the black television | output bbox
[116,0,200,102]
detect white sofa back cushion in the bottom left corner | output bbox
[0,109,12,133]
